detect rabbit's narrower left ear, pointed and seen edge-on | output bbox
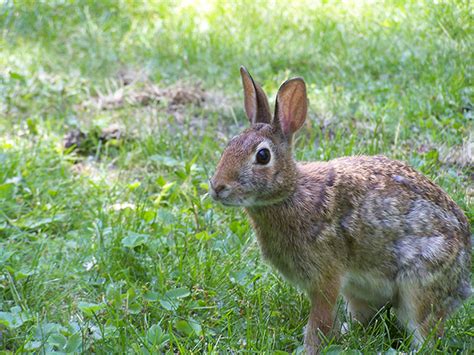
[240,66,272,124]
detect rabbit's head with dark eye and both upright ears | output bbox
[210,67,308,207]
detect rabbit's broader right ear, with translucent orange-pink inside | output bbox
[274,78,308,140]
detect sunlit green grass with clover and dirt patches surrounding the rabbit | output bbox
[0,0,474,353]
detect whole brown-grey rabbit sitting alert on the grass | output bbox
[210,67,471,354]
